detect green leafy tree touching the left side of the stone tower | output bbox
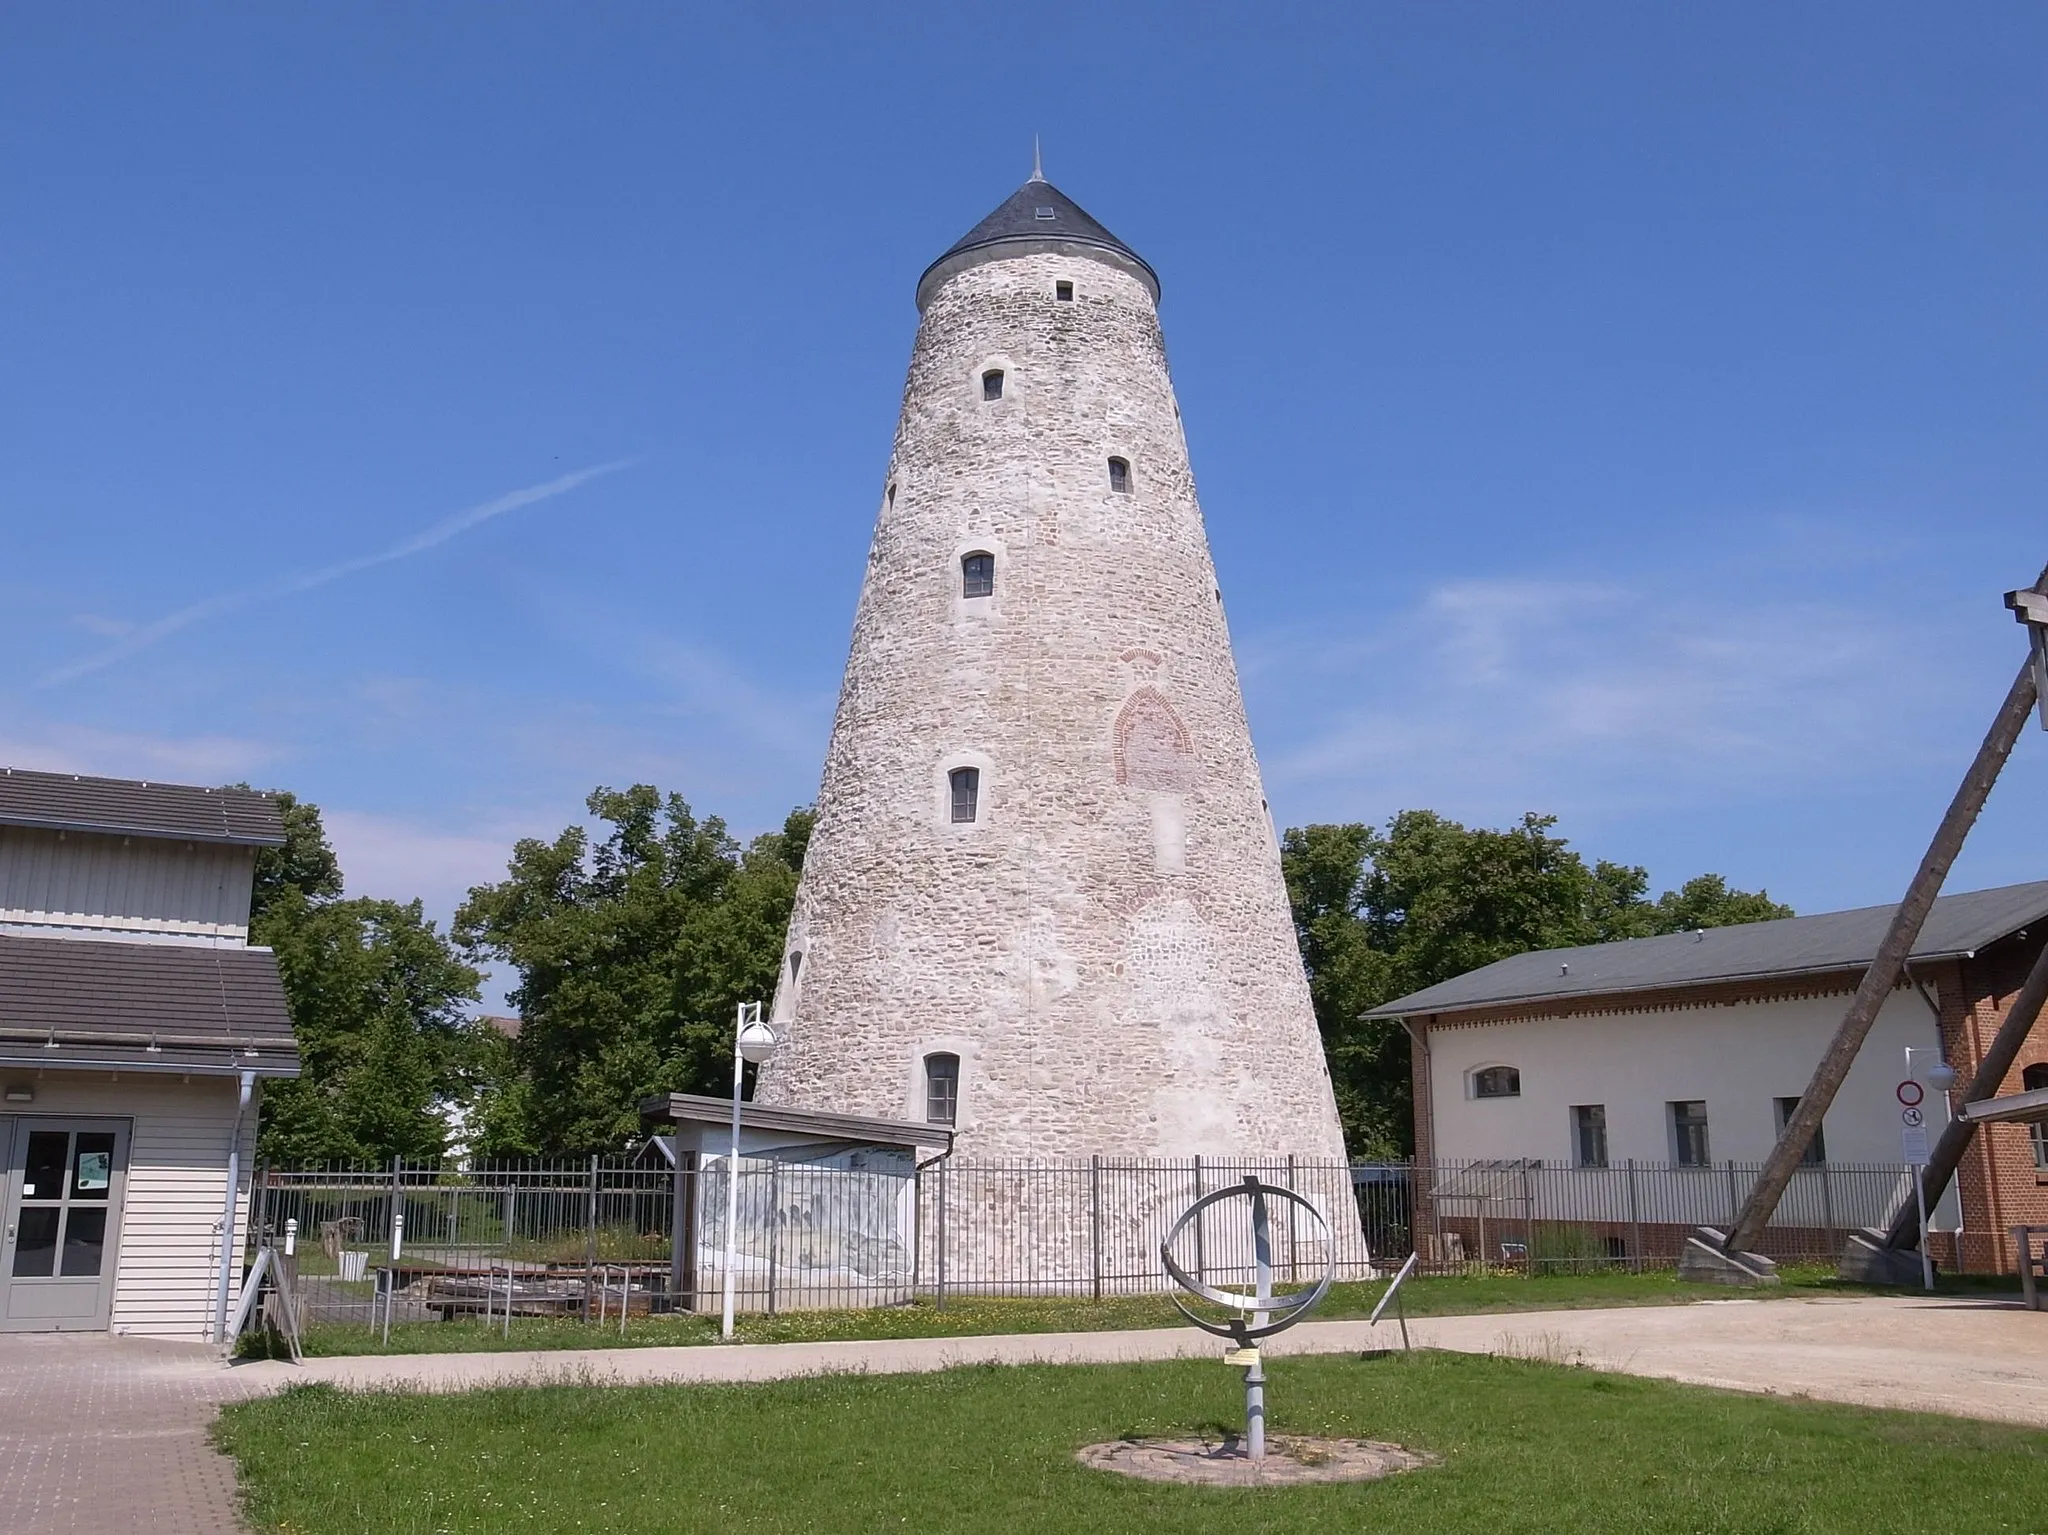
[455,784,811,1154]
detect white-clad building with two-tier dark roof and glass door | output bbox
[0,770,299,1341]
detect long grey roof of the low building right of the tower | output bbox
[1366,880,2048,1017]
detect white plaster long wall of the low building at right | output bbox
[1430,991,1942,1167]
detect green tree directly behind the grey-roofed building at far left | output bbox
[250,794,481,1160]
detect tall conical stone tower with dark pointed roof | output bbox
[758,174,1343,1160]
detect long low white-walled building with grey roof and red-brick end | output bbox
[1368,882,2048,1269]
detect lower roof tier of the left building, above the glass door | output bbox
[0,935,299,1077]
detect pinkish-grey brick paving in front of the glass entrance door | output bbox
[0,1332,262,1535]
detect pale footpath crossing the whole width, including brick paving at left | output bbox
[0,1296,2048,1535]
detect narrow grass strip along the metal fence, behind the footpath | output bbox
[242,1267,2017,1357]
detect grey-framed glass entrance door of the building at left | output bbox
[0,1117,127,1332]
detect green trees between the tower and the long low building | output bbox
[1280,810,1792,1158]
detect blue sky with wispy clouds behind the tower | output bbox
[0,4,2048,974]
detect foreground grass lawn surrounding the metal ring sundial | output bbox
[217,1353,2048,1535]
